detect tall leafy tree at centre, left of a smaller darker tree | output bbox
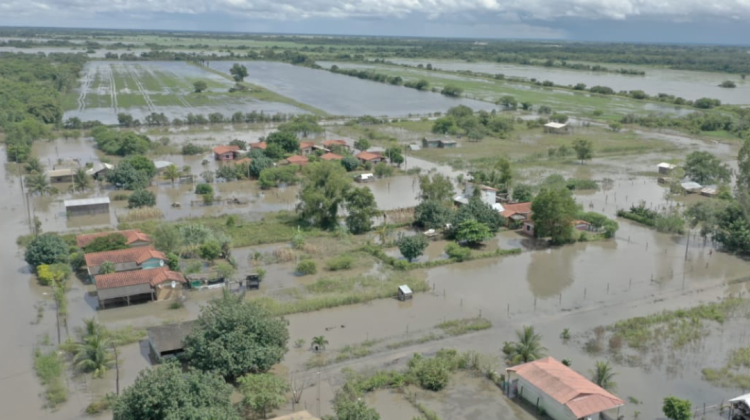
[297,161,351,229]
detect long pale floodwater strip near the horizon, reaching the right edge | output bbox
[388,58,750,104]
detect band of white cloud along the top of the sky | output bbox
[0,0,750,24]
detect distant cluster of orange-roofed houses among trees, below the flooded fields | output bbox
[212,140,388,166]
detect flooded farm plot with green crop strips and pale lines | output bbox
[63,61,303,124]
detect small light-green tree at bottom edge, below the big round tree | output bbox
[238,373,289,419]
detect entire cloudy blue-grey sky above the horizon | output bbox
[0,0,750,44]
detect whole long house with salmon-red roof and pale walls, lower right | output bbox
[506,357,625,420]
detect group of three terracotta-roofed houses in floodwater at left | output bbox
[76,229,185,309]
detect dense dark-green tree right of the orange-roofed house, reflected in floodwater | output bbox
[531,188,578,244]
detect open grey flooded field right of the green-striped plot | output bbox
[210,61,494,117]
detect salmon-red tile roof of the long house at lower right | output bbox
[508,357,625,419]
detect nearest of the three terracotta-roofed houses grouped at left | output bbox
[94,267,185,309]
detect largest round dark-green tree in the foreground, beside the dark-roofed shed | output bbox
[183,291,289,378]
